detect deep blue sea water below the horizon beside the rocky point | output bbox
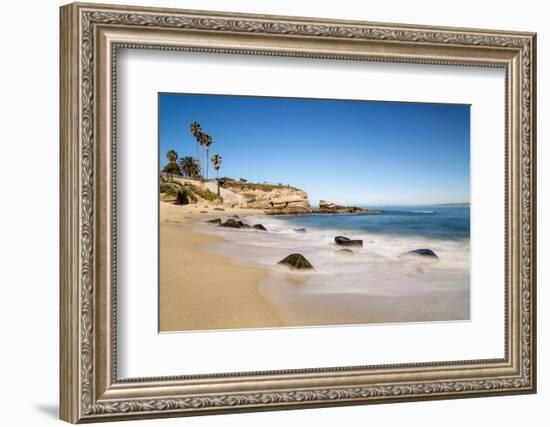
[268,206,470,244]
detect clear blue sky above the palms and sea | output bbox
[159,93,470,206]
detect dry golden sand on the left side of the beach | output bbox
[160,202,284,332]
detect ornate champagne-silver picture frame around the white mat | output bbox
[60,3,536,423]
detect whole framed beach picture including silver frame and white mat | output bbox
[60,4,536,423]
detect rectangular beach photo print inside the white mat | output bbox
[157,93,470,332]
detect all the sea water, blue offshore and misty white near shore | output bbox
[199,206,470,326]
